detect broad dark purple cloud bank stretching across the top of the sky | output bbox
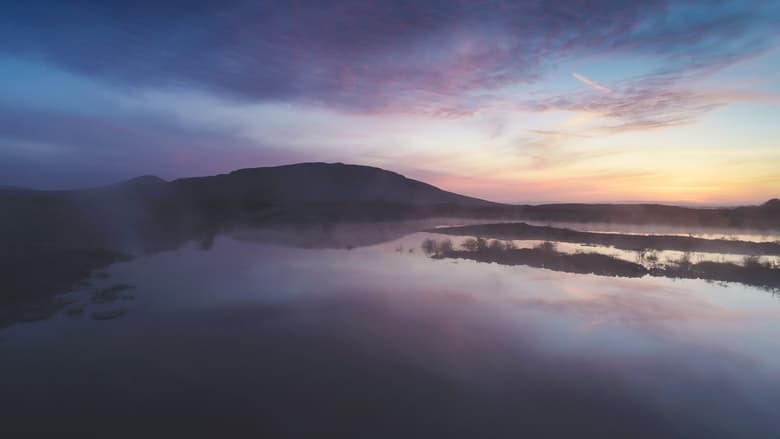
[0,0,780,116]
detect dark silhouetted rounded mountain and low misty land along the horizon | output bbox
[0,162,780,241]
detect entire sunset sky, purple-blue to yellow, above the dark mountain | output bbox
[0,0,780,205]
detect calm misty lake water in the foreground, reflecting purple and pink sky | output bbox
[0,230,780,438]
